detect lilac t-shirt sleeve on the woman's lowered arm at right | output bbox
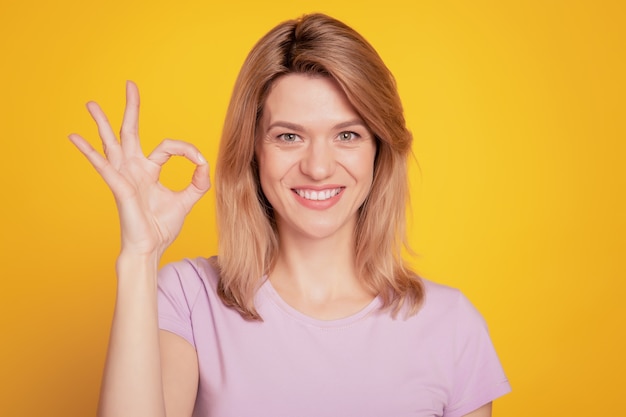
[444,294,511,417]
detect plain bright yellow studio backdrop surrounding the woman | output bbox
[0,0,626,417]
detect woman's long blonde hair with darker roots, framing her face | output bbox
[215,14,424,320]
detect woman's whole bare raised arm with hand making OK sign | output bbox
[69,82,210,417]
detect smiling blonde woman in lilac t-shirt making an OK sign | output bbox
[70,14,510,417]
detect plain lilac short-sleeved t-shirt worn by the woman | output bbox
[159,258,510,417]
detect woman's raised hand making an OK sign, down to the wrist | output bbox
[69,81,210,256]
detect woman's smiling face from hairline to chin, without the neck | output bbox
[256,74,376,239]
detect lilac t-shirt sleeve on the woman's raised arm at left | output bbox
[157,261,198,348]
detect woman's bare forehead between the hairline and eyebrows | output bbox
[263,74,360,126]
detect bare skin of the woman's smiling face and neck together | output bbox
[256,74,376,320]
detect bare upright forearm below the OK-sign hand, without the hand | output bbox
[98,253,165,417]
